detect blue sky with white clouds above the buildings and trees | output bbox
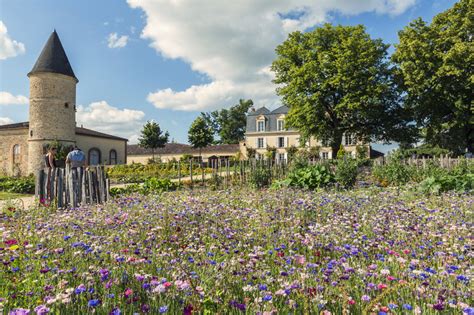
[0,0,455,151]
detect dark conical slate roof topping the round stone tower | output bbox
[28,30,77,80]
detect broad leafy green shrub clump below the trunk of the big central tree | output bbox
[284,164,334,189]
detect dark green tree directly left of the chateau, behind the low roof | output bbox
[201,99,253,144]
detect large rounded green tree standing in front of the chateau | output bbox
[272,24,410,156]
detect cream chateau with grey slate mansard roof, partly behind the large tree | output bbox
[241,106,372,161]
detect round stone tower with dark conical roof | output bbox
[28,31,79,174]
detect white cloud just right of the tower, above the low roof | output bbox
[76,101,145,143]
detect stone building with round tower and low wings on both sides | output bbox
[0,31,128,175]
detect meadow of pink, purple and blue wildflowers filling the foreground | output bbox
[0,189,474,315]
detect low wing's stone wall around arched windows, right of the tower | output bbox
[76,134,127,165]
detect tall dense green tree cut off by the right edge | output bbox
[392,0,474,154]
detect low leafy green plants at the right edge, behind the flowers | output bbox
[419,173,474,195]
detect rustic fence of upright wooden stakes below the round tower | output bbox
[35,166,110,208]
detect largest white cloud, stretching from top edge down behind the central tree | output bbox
[127,0,417,110]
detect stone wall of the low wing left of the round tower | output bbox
[0,128,28,176]
